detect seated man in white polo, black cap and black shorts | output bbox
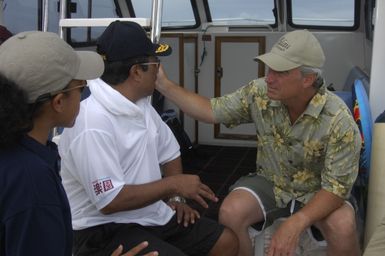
[59,21,238,256]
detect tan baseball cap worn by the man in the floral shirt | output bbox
[254,29,325,71]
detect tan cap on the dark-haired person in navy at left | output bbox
[0,31,104,103]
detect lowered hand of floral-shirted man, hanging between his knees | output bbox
[268,215,304,256]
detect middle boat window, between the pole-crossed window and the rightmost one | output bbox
[206,0,276,25]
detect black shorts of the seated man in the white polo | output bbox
[73,215,224,256]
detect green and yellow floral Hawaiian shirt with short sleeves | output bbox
[211,78,361,207]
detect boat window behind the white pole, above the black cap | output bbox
[131,0,200,29]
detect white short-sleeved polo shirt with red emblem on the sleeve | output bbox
[59,79,180,230]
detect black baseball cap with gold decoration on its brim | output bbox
[96,20,172,62]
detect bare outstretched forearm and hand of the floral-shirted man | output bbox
[156,66,215,123]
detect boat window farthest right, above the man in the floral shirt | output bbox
[288,0,359,29]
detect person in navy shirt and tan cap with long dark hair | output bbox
[0,31,156,256]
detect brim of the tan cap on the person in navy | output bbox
[74,51,104,80]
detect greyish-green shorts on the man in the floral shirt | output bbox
[230,173,303,230]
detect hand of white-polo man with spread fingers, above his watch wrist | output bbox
[169,174,218,208]
